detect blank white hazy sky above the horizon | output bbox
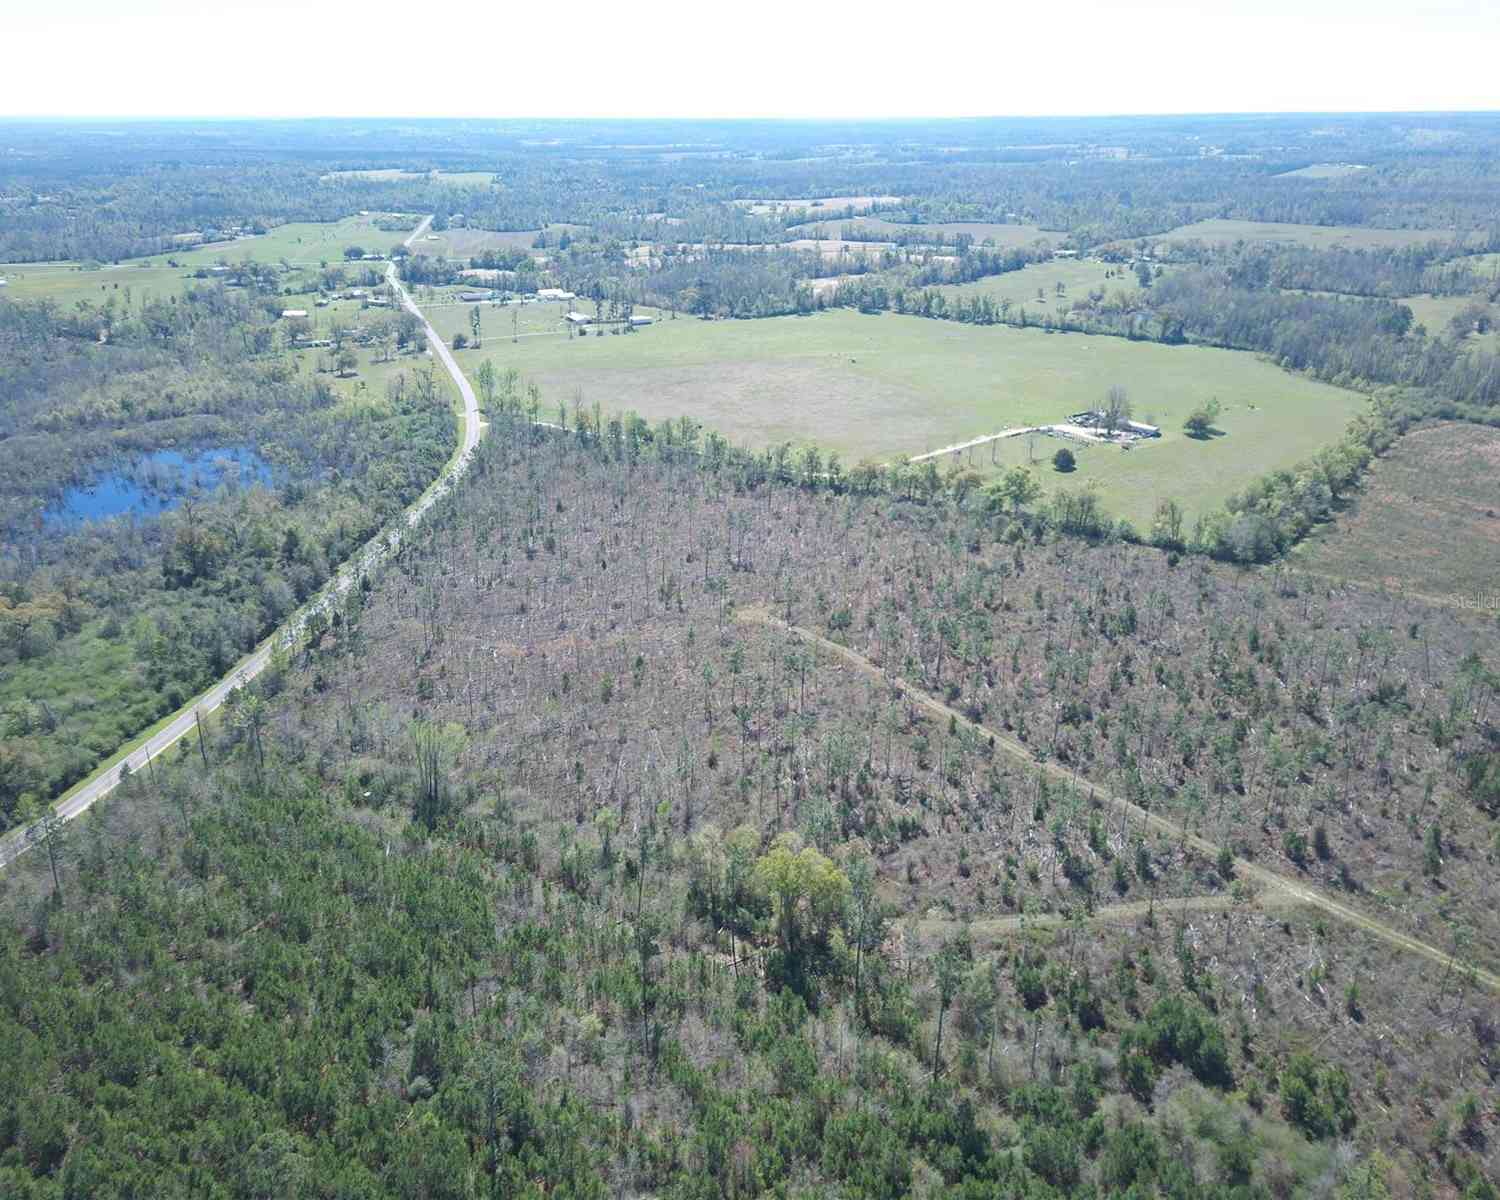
[0,0,1500,117]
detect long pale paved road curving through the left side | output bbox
[0,216,483,869]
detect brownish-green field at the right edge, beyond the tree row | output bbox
[1296,422,1500,612]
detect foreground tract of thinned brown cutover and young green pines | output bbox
[0,411,1500,1200]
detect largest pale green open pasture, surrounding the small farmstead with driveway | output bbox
[432,308,1364,522]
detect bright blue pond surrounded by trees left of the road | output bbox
[44,446,272,525]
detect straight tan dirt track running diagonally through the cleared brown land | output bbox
[737,608,1500,993]
